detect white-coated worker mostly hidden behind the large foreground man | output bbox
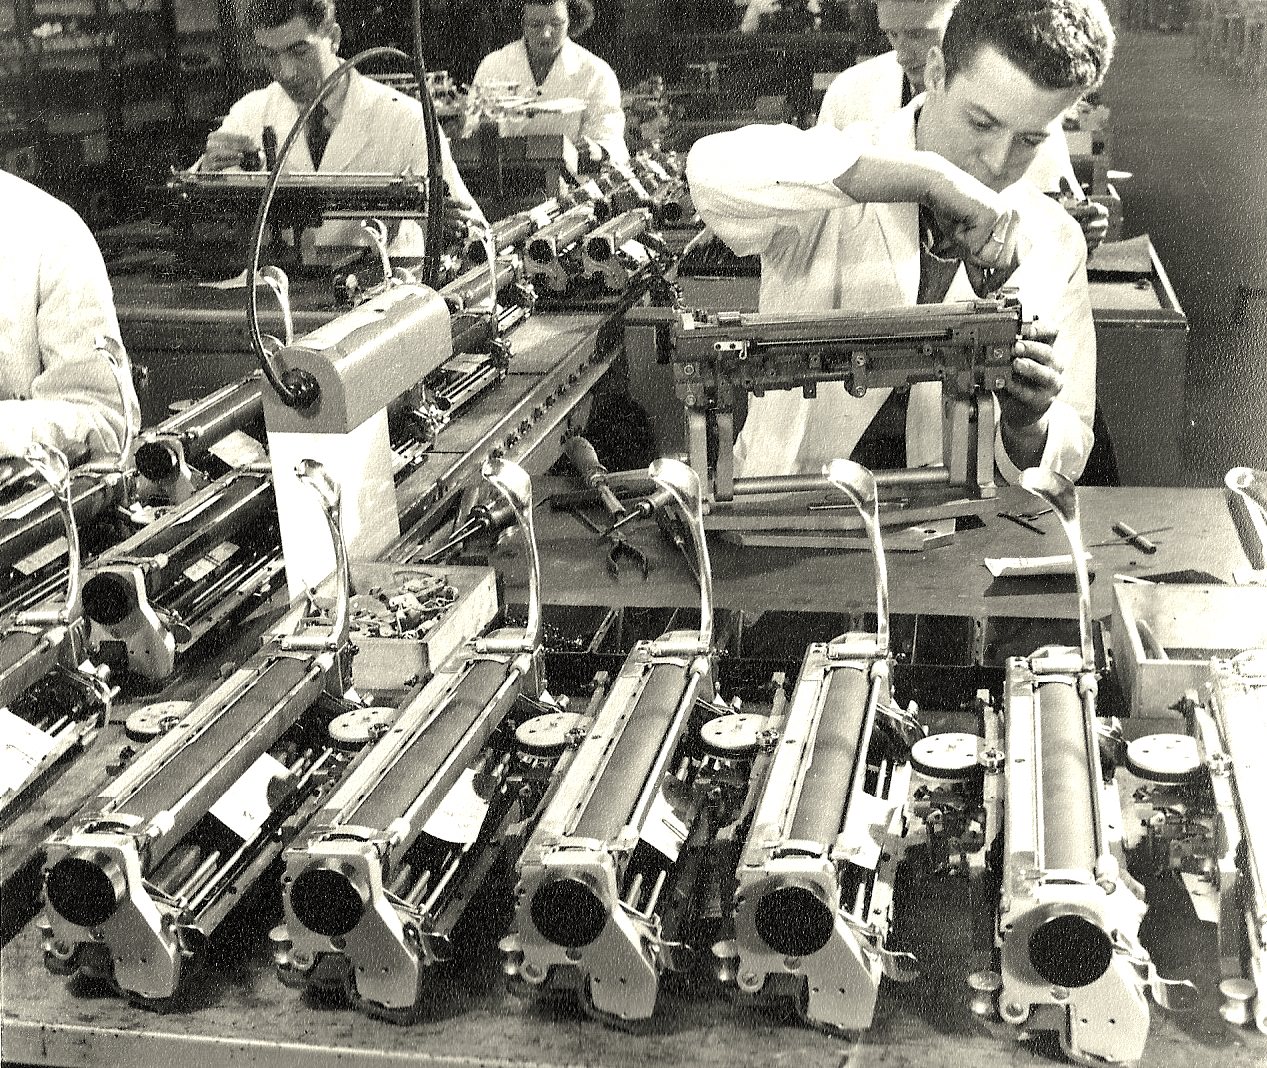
[818,0,1109,252]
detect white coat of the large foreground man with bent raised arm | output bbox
[687,99,1096,481]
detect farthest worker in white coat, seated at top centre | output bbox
[471,0,630,163]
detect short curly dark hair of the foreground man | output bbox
[941,0,1116,92]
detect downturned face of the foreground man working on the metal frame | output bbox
[919,46,1082,193]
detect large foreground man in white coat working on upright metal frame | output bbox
[687,0,1114,480]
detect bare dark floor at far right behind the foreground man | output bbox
[1105,30,1267,485]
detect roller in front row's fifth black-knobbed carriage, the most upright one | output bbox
[1038,682,1100,872]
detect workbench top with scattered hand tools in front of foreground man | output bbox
[511,483,1245,620]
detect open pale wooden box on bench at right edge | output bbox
[1110,582,1267,720]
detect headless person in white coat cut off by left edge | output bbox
[0,171,141,462]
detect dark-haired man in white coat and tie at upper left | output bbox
[198,0,483,255]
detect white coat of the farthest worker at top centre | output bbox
[471,38,630,163]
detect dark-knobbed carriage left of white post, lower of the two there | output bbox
[84,470,284,679]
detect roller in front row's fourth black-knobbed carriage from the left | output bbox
[788,666,870,844]
